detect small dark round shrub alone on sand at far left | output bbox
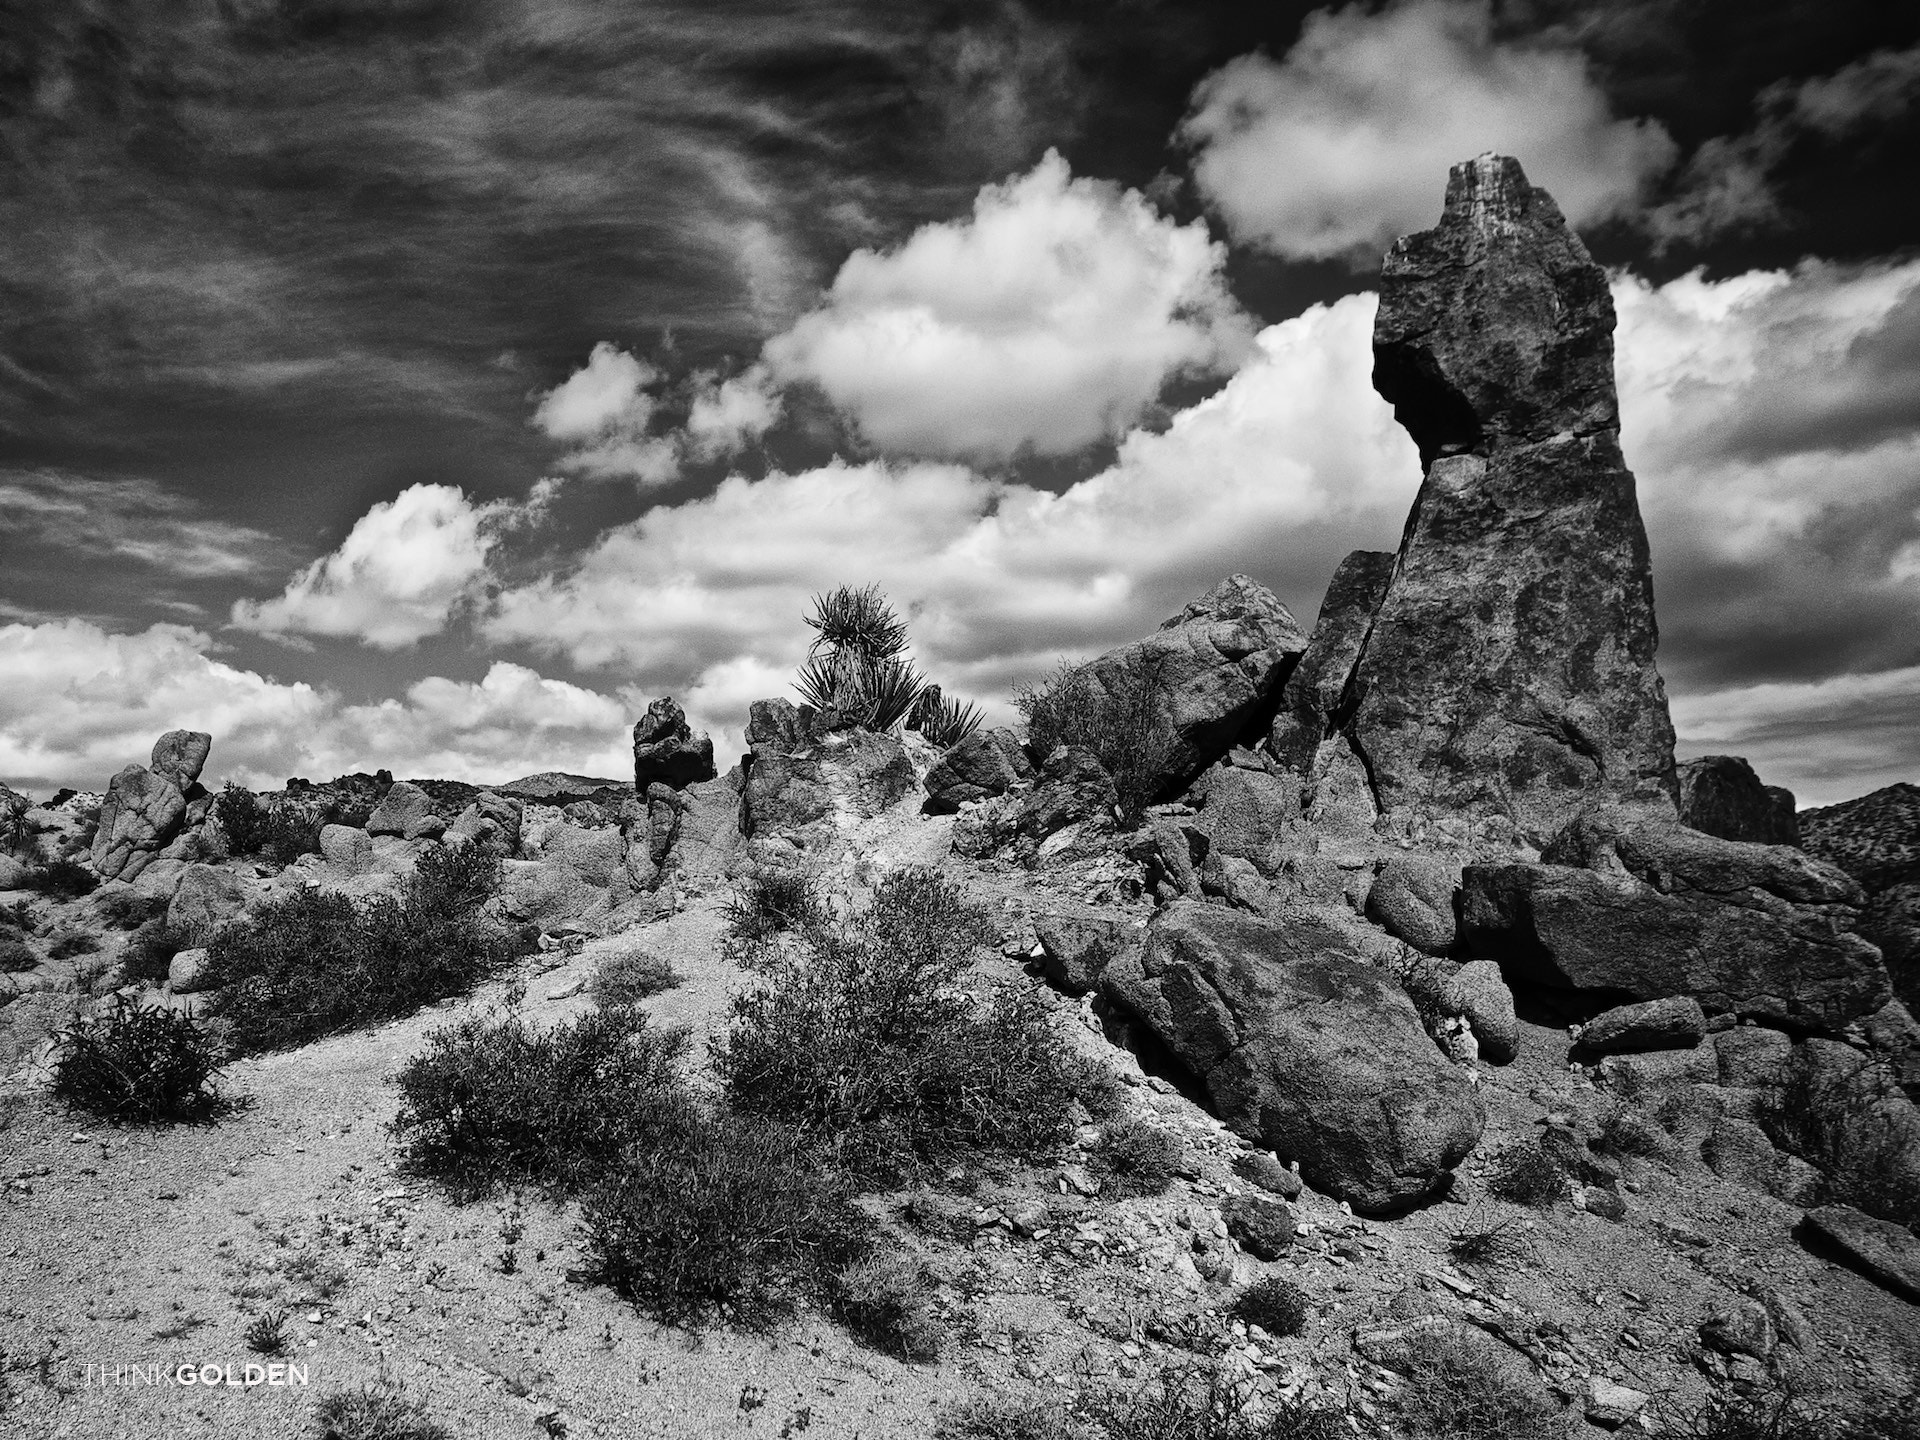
[54,1000,221,1121]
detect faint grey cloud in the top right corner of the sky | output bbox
[1644,46,1920,248]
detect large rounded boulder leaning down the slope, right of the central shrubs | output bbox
[1100,900,1486,1210]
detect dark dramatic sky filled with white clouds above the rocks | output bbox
[0,0,1920,804]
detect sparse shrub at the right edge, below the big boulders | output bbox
[1761,1058,1920,1225]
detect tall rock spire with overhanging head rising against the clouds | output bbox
[1281,156,1674,845]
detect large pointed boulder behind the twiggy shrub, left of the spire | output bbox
[1081,574,1308,795]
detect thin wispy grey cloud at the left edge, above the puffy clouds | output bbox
[0,470,284,580]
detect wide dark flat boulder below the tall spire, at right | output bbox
[1461,810,1891,1029]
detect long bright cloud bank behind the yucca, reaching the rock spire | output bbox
[482,296,1419,768]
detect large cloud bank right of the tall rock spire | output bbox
[1613,261,1920,803]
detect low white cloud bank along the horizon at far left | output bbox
[0,620,637,791]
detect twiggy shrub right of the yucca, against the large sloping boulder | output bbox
[1014,657,1173,820]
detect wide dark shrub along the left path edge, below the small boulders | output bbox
[207,845,515,1052]
